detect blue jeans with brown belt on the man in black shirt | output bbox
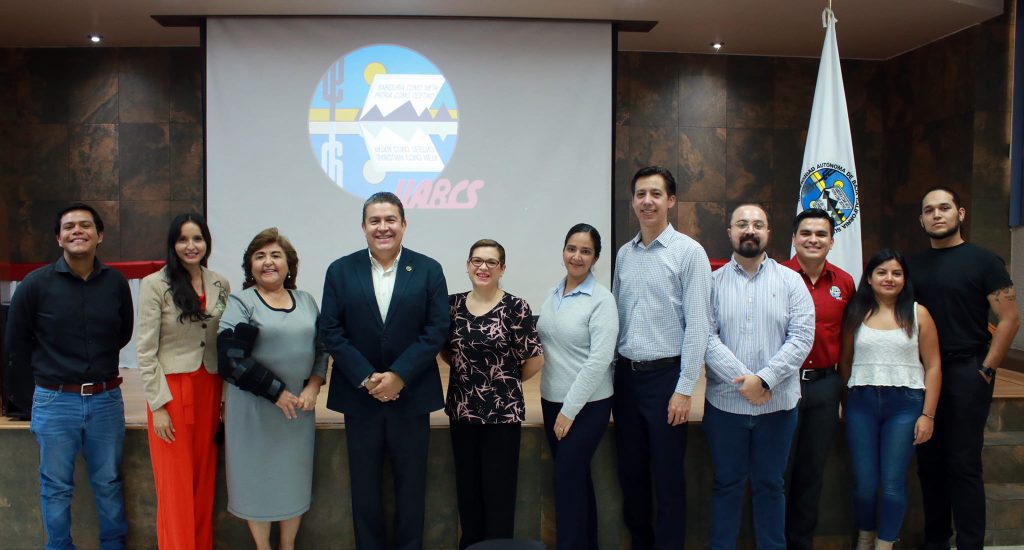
[32,386,128,550]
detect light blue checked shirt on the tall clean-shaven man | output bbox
[611,224,712,395]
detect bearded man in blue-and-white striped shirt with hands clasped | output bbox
[703,204,814,550]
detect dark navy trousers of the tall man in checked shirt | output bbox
[612,363,689,550]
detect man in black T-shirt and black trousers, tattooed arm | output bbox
[908,186,1020,550]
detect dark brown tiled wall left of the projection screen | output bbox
[0,48,204,262]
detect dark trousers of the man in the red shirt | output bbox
[785,369,843,550]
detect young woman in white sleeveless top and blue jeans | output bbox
[840,249,942,550]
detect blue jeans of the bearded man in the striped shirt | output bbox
[703,401,797,550]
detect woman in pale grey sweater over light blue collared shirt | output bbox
[537,223,618,550]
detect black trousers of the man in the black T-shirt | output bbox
[918,354,994,550]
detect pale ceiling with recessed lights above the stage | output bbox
[0,0,1004,59]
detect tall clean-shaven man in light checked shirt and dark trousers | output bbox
[606,166,711,550]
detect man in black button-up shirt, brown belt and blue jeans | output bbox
[7,203,133,550]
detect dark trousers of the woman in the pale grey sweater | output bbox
[541,397,612,550]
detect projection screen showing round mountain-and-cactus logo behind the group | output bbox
[206,17,614,311]
